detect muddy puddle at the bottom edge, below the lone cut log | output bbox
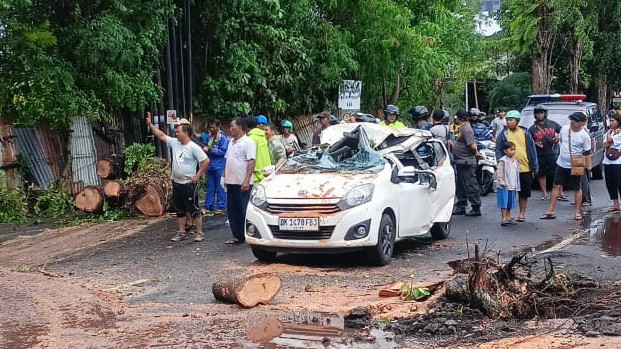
[246,312,398,349]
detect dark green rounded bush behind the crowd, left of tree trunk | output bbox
[488,73,530,110]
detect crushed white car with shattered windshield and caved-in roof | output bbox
[246,123,455,265]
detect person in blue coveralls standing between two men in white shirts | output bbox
[201,120,229,216]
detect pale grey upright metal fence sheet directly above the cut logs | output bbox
[69,116,101,186]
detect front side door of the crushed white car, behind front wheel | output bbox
[393,150,431,237]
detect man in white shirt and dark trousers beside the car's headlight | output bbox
[223,118,257,244]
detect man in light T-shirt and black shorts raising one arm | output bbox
[146,113,209,242]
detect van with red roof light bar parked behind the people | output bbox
[520,94,606,179]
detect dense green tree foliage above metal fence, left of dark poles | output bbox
[0,0,175,129]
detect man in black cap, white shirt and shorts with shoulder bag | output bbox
[539,112,591,220]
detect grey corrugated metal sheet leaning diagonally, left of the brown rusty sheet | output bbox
[15,128,54,188]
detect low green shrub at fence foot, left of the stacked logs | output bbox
[30,183,75,219]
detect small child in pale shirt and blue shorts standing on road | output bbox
[496,141,520,227]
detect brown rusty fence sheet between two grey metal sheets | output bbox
[35,122,69,180]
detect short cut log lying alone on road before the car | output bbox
[211,273,282,308]
